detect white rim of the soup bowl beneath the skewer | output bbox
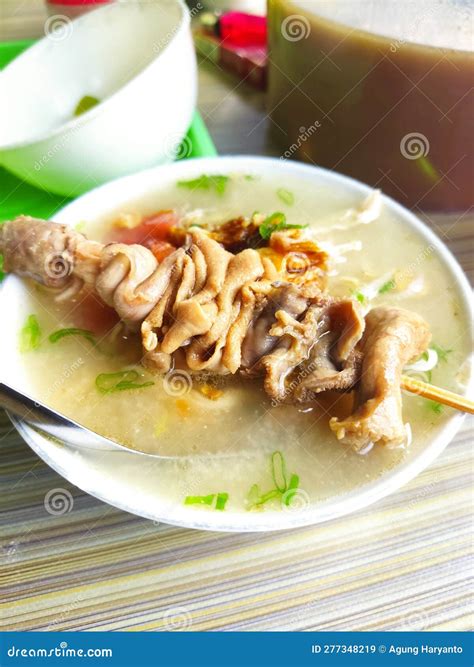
[0,156,472,532]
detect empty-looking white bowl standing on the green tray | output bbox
[0,0,197,196]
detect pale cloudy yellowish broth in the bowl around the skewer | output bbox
[16,174,470,511]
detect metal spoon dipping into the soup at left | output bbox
[0,382,160,459]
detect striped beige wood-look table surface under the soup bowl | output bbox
[0,0,474,630]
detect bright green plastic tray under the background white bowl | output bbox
[0,40,217,224]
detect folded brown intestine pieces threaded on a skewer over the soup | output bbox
[0,216,430,450]
